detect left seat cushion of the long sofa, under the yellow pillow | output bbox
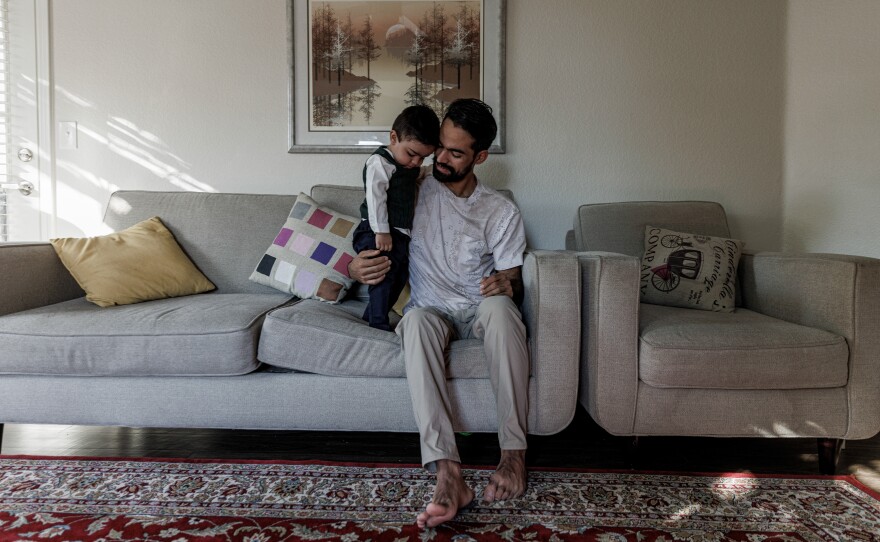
[0,293,290,376]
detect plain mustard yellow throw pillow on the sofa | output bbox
[49,216,215,307]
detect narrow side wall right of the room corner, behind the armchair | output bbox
[784,0,880,258]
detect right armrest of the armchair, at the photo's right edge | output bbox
[738,252,880,439]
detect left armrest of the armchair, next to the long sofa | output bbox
[577,252,640,435]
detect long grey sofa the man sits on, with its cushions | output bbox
[0,185,580,444]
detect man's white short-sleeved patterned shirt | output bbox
[405,174,526,312]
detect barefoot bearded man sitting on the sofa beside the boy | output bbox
[349,99,529,528]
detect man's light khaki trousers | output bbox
[396,296,529,466]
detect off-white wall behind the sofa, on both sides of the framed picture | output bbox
[52,0,786,249]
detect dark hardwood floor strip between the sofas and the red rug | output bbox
[2,409,880,491]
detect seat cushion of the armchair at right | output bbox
[639,303,849,390]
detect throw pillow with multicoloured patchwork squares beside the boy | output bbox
[250,193,361,303]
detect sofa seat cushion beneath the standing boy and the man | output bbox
[257,299,489,380]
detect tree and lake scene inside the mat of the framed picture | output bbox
[308,0,482,130]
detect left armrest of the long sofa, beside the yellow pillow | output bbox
[0,243,85,316]
